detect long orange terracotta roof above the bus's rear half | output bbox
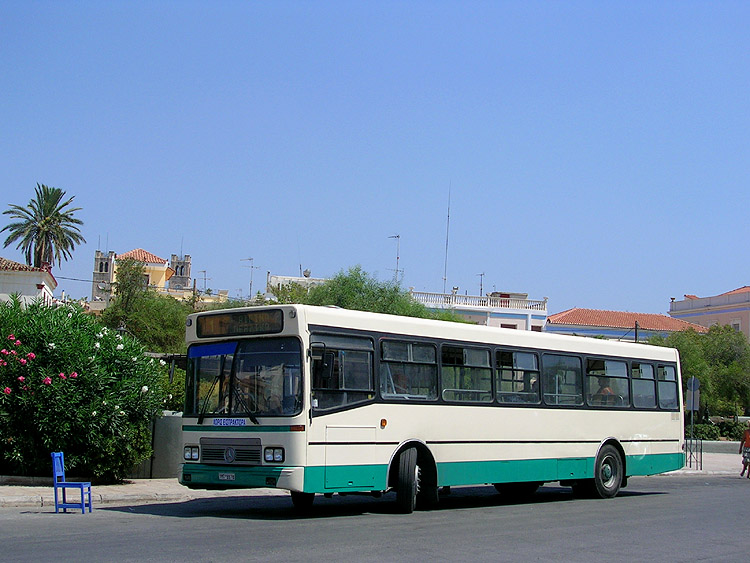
[547,307,708,332]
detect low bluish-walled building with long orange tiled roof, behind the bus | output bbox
[545,307,706,341]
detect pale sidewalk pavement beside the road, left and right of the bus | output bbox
[0,453,742,510]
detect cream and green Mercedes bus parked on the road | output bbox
[180,305,684,513]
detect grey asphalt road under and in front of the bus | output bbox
[0,475,750,562]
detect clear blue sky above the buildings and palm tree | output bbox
[0,1,750,313]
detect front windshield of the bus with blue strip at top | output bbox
[185,338,302,419]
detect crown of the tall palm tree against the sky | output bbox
[0,184,86,268]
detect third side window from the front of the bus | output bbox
[440,346,492,403]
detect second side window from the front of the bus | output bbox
[380,340,437,401]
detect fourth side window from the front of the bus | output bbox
[495,350,539,404]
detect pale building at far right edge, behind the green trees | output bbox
[669,285,750,339]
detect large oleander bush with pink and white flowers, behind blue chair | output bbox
[0,300,166,482]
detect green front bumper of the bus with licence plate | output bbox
[179,463,305,491]
